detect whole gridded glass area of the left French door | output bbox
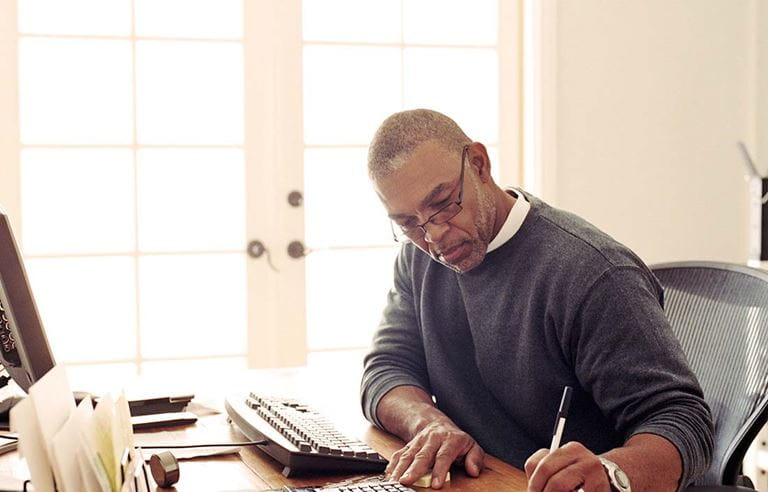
[6,0,247,392]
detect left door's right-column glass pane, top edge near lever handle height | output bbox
[139,254,247,357]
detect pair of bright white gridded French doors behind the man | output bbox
[0,0,520,389]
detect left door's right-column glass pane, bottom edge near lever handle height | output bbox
[138,149,245,251]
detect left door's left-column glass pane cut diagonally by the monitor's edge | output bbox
[26,257,136,363]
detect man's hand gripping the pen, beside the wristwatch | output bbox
[525,442,611,492]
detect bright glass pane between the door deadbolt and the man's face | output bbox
[304,148,392,248]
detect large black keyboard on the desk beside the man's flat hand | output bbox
[224,393,387,477]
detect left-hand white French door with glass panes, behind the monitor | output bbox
[0,0,306,388]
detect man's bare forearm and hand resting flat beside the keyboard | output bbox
[377,386,485,489]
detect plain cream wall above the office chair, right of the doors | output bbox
[543,0,756,263]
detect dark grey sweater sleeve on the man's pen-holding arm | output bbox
[564,267,714,488]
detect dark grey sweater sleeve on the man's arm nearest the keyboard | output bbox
[360,245,431,428]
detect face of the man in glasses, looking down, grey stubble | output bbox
[374,142,495,272]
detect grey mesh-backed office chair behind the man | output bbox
[651,262,768,492]
